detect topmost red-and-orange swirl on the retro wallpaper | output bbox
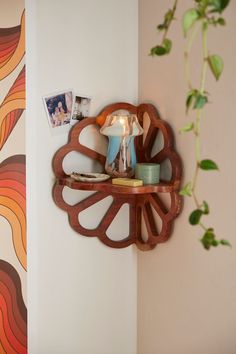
[0,11,25,80]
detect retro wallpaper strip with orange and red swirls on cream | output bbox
[0,0,27,354]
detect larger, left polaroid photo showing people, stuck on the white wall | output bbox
[43,90,74,130]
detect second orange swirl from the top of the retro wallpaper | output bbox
[0,67,25,150]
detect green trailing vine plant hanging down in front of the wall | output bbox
[150,0,230,249]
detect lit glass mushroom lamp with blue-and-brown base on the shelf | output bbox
[100,114,143,177]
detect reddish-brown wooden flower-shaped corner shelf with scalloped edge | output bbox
[53,103,182,250]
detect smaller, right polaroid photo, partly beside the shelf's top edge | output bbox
[70,94,91,125]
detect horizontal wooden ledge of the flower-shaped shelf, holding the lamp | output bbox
[57,177,178,194]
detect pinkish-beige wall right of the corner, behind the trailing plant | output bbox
[138,0,236,354]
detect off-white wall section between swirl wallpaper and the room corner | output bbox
[26,0,138,354]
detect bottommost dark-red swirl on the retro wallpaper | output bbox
[0,260,27,354]
